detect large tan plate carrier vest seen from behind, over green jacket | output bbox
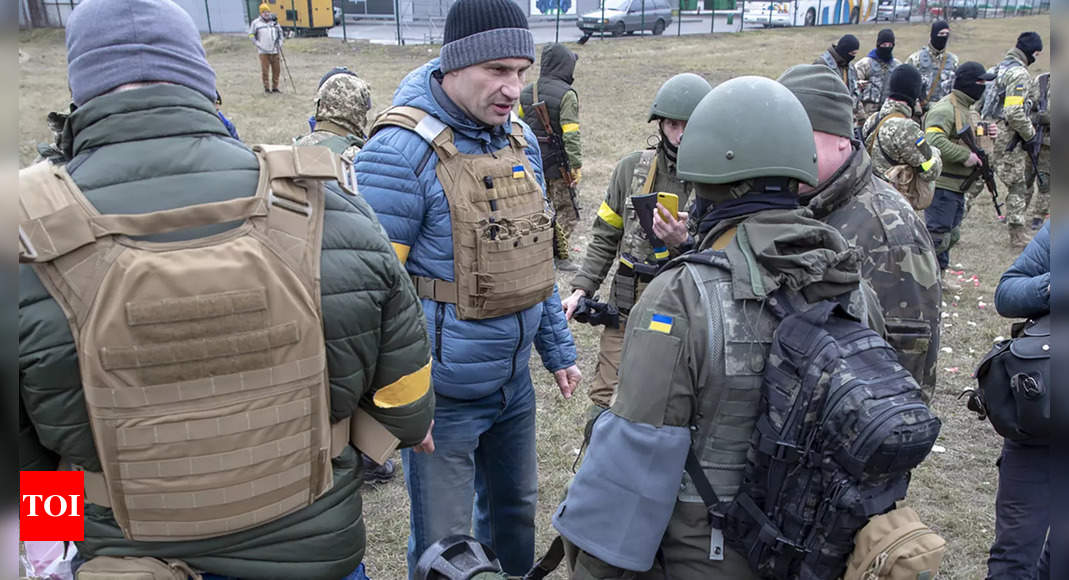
[19,145,355,542]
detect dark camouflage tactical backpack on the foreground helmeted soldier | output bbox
[687,294,941,580]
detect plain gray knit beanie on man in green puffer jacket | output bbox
[66,0,215,106]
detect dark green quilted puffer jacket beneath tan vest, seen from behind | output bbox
[18,84,434,580]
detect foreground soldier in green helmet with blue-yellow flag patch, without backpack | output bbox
[553,77,879,580]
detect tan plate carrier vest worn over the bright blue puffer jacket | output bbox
[370,107,555,319]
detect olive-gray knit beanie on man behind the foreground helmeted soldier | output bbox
[776,64,854,139]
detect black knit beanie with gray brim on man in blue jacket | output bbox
[440,0,535,73]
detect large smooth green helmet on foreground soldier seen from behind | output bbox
[678,76,817,189]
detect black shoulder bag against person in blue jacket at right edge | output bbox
[969,314,1053,443]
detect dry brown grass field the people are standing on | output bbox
[18,16,1050,580]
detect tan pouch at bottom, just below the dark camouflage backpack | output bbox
[842,507,946,580]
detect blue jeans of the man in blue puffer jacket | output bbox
[401,364,538,579]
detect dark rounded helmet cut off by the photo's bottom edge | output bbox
[413,534,508,580]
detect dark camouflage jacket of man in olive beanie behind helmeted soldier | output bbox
[806,148,942,401]
